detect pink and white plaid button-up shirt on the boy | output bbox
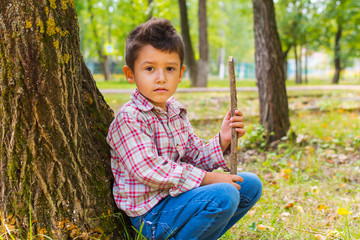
[107,90,227,217]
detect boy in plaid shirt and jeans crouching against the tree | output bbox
[107,18,262,240]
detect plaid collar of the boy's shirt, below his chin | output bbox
[131,89,186,117]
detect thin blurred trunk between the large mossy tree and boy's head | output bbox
[88,1,111,81]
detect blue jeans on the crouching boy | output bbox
[131,172,262,240]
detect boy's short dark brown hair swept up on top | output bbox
[125,18,185,70]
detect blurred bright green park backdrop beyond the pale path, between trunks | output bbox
[76,0,360,88]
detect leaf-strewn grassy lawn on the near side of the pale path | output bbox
[105,91,360,240]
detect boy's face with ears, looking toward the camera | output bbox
[123,44,185,111]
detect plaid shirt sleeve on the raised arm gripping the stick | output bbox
[183,121,229,171]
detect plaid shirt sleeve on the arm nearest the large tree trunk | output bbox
[108,112,205,196]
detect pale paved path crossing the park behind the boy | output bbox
[100,85,360,94]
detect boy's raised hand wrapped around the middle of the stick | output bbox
[220,109,245,152]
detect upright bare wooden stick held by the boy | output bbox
[228,56,238,174]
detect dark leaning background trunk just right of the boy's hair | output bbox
[179,0,198,87]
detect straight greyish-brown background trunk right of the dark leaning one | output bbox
[197,0,209,87]
